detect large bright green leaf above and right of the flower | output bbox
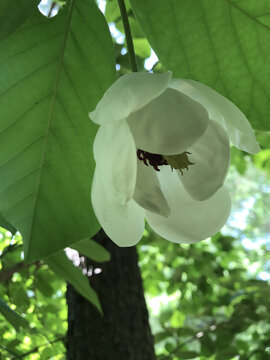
[131,0,270,130]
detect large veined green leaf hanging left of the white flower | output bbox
[0,0,115,261]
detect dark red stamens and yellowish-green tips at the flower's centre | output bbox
[137,149,194,175]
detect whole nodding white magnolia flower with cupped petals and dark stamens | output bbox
[89,72,259,246]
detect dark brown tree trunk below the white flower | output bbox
[67,232,155,360]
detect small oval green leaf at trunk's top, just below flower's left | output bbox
[70,239,111,262]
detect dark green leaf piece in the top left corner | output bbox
[0,0,39,40]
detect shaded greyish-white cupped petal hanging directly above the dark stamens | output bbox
[127,89,209,155]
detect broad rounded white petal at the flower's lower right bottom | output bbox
[146,166,231,243]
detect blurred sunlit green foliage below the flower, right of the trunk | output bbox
[140,224,270,360]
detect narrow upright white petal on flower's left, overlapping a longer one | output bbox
[94,120,137,205]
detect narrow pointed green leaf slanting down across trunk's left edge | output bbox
[44,251,102,312]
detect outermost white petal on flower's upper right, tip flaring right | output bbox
[170,79,260,154]
